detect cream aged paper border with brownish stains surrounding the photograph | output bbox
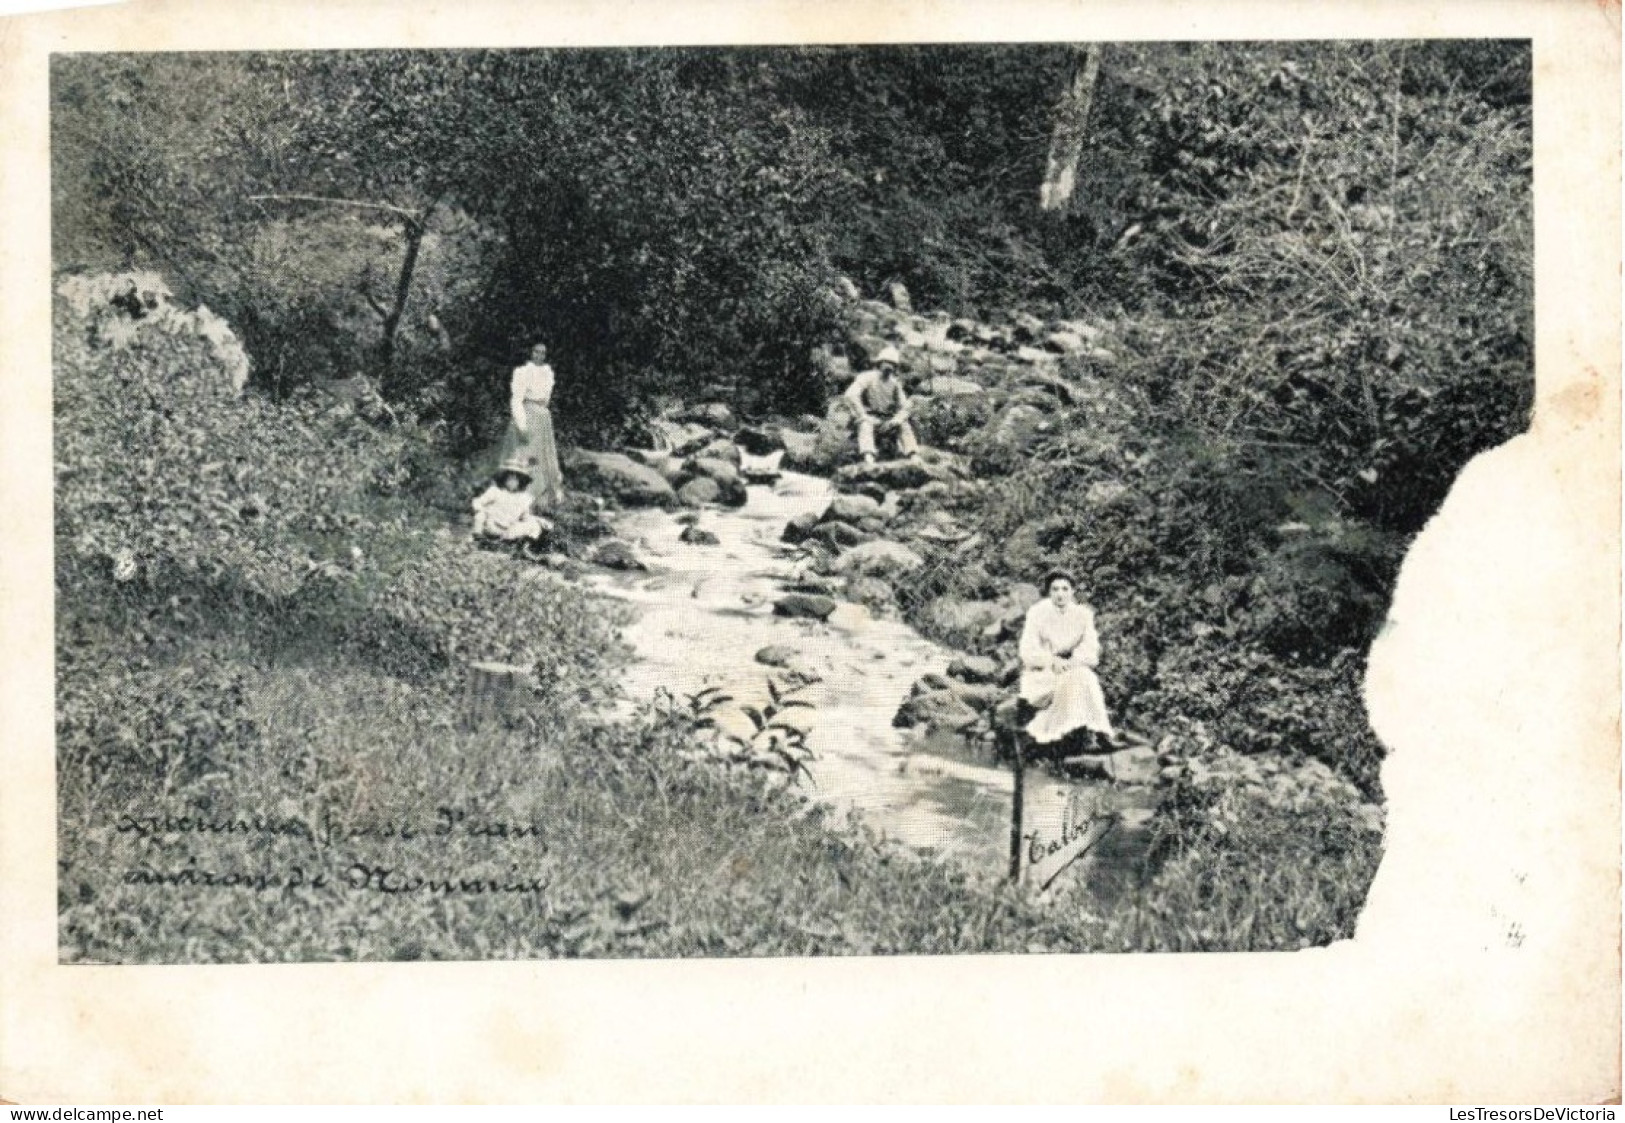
[0,0,1620,1103]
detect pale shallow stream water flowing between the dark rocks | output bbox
[590,473,1149,895]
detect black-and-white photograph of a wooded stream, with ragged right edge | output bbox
[50,41,1534,964]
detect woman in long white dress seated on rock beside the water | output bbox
[1021,569,1116,751]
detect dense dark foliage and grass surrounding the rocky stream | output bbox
[52,41,1532,959]
